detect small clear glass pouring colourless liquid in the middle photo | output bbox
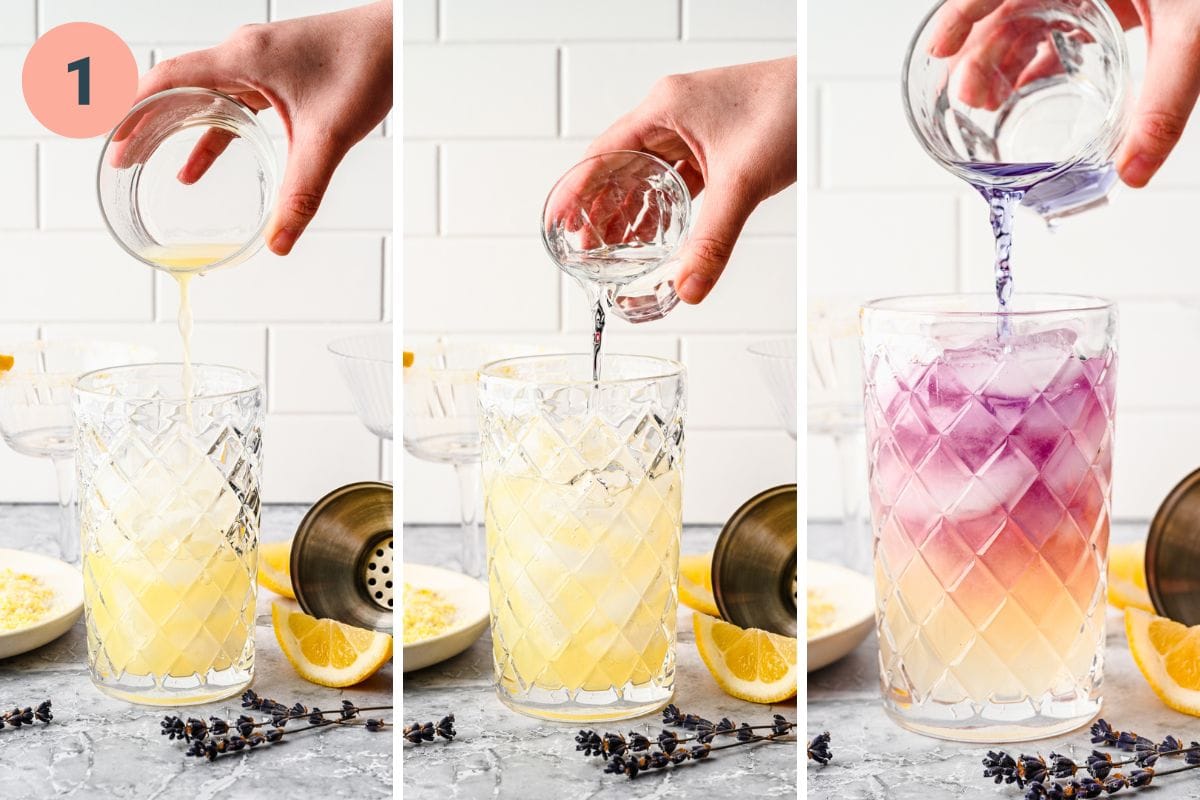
[541,150,691,323]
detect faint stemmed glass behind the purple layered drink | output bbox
[808,305,869,571]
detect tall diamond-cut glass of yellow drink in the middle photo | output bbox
[479,354,685,721]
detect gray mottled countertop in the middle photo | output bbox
[403,525,798,800]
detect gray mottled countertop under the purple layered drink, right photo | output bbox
[806,523,1200,800]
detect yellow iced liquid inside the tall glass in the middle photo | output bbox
[487,462,682,717]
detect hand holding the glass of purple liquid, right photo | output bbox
[930,0,1200,187]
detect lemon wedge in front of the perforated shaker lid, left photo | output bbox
[271,603,391,688]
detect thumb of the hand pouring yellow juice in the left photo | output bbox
[266,133,347,255]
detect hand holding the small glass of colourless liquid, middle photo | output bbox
[587,56,796,303]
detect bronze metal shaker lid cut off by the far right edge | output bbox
[1146,469,1200,625]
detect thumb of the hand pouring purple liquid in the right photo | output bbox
[1117,37,1200,188]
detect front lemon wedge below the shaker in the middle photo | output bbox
[691,612,796,703]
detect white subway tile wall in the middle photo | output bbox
[402,0,798,523]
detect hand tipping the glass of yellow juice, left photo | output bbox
[124,0,392,255]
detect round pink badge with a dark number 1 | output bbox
[20,23,138,139]
